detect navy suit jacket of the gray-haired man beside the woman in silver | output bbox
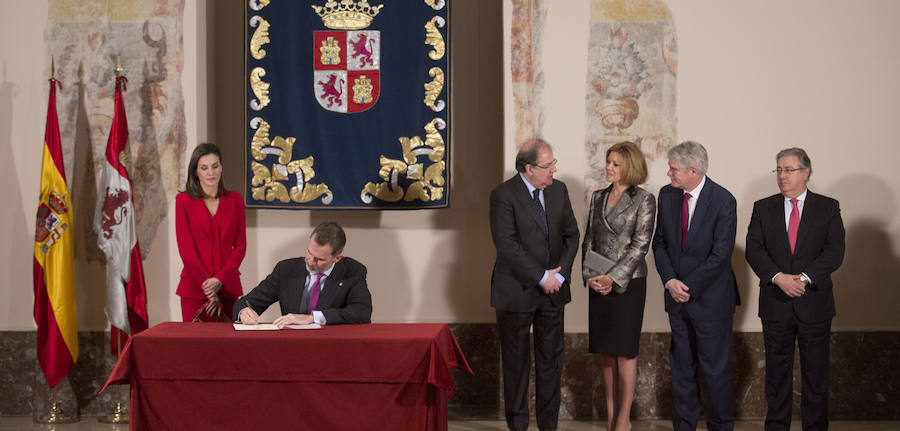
[653,177,740,320]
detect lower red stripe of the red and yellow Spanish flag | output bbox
[34,259,75,389]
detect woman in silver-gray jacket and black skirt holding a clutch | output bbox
[582,142,656,431]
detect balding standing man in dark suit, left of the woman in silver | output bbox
[490,139,579,430]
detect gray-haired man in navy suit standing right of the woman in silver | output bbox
[653,141,740,431]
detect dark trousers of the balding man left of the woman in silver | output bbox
[497,296,565,430]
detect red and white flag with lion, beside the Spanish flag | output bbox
[94,76,147,350]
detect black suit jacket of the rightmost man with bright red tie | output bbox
[746,192,844,322]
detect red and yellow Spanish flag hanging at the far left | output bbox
[34,78,78,388]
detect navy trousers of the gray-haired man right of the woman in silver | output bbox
[669,309,734,431]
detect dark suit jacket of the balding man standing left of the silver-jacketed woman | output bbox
[490,173,579,312]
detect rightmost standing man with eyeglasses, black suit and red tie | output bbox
[746,148,844,431]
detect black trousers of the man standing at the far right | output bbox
[762,316,831,431]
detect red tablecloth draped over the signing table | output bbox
[106,322,471,431]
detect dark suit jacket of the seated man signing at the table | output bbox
[232,257,372,325]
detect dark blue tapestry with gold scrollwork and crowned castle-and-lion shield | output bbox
[245,0,451,209]
